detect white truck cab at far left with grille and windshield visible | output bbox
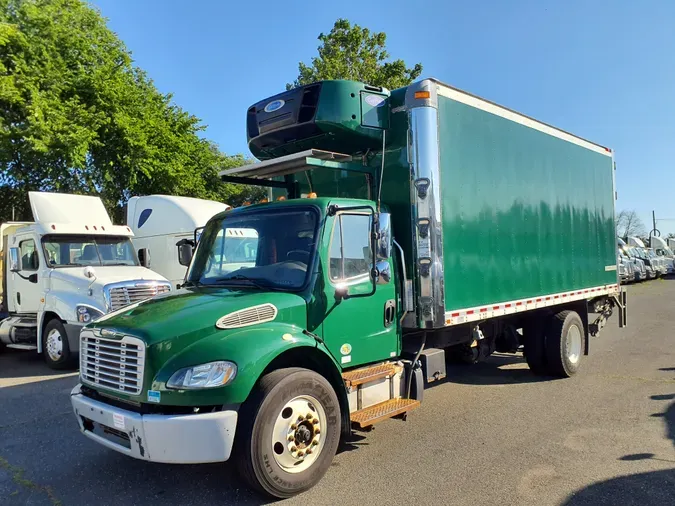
[0,192,171,369]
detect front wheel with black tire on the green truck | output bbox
[234,367,342,499]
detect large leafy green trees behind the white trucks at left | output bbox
[0,0,262,222]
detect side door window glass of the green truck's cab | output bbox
[330,214,373,281]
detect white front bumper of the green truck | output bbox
[70,385,237,464]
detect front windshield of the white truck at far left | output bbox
[42,235,138,267]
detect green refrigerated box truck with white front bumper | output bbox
[71,79,626,497]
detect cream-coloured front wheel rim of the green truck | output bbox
[271,395,326,473]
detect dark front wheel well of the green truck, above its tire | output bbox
[260,346,351,438]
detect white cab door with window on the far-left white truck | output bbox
[7,234,42,314]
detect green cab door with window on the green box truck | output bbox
[321,210,400,367]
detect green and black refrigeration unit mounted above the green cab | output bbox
[246,81,389,160]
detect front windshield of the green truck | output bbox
[188,208,318,289]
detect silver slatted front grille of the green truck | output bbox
[80,331,145,395]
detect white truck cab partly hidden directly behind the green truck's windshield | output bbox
[127,195,230,287]
